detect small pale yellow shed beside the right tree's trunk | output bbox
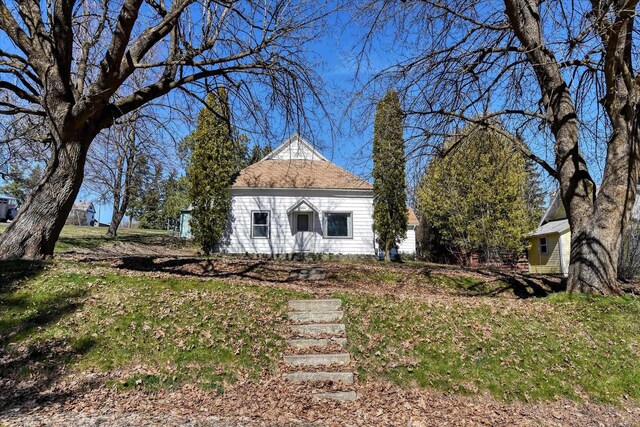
[528,188,640,276]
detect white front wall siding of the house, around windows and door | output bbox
[220,189,375,255]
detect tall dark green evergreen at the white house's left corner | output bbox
[186,87,247,255]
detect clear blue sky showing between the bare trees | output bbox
[0,4,568,222]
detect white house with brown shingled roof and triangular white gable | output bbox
[180,135,418,255]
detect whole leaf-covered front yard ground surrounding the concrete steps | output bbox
[0,244,640,426]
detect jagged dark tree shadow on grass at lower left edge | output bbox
[0,261,95,412]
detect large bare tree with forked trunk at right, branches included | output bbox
[356,0,640,294]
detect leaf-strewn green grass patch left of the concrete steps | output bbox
[0,263,306,390]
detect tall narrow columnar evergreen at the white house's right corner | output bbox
[373,90,408,261]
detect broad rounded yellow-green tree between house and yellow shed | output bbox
[419,127,539,264]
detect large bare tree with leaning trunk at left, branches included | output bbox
[0,0,327,259]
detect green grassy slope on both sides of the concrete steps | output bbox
[0,227,640,402]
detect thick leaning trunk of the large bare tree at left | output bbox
[0,140,89,259]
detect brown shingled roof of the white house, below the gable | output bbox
[232,160,371,190]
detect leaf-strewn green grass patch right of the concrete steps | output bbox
[337,293,640,402]
